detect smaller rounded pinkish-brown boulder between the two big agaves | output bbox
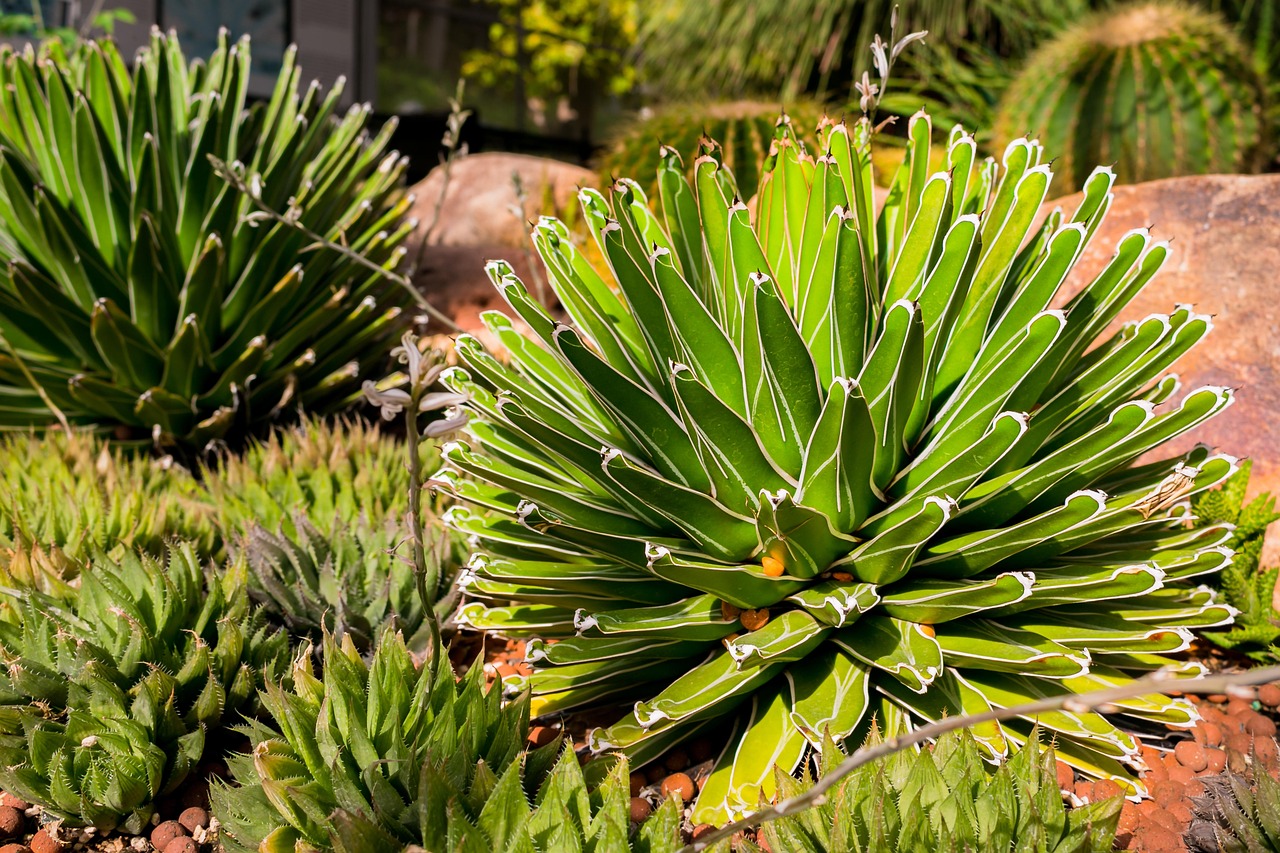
[410,151,596,252]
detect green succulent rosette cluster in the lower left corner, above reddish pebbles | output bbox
[0,546,288,833]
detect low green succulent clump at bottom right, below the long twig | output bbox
[740,730,1124,853]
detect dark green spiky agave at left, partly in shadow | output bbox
[0,31,412,450]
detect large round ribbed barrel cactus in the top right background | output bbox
[996,0,1267,192]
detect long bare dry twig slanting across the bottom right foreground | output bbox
[680,666,1280,853]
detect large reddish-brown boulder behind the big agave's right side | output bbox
[1048,175,1280,564]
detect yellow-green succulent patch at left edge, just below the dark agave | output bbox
[0,433,215,594]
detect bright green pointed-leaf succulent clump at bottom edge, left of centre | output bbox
[212,631,680,853]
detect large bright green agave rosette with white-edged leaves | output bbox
[435,114,1235,822]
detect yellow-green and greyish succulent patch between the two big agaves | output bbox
[204,420,463,637]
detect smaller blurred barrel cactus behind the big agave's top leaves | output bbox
[599,101,822,200]
